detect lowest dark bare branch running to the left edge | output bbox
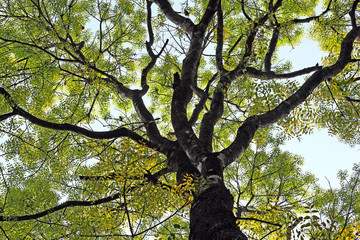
[0,193,121,222]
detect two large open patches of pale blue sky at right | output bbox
[279,36,360,188]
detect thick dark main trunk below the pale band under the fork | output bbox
[189,182,247,240]
